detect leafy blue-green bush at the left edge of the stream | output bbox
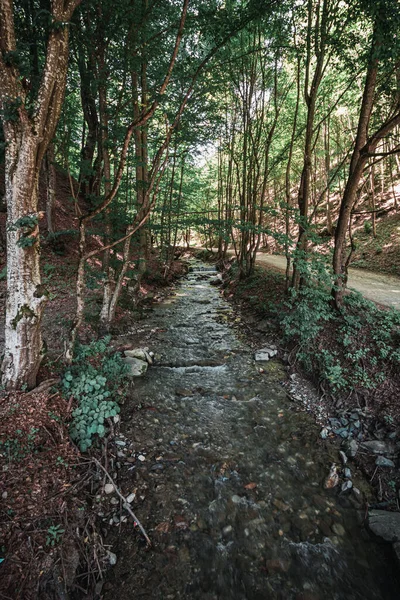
[62,336,128,452]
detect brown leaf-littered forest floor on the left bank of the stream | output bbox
[0,245,186,600]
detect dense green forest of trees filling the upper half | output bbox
[0,0,400,388]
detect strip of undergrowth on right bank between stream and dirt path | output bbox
[228,267,400,406]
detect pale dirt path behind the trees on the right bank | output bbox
[256,252,400,309]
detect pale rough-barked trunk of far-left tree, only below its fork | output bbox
[3,127,47,389]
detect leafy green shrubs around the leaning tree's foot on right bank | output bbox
[279,285,400,394]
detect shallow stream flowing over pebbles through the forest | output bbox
[106,262,400,600]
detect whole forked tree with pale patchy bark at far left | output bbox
[0,0,80,389]
